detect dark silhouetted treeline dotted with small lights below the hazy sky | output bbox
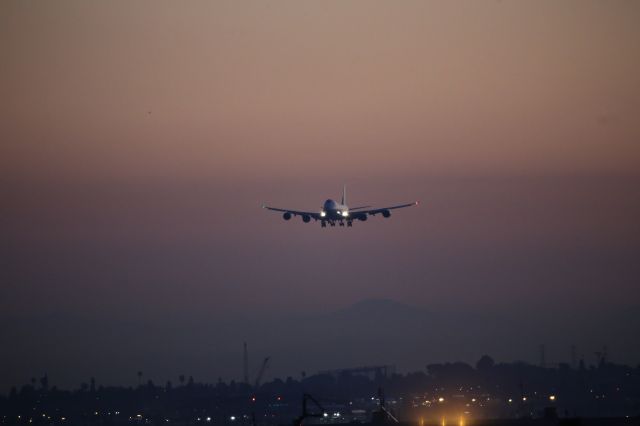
[0,356,640,424]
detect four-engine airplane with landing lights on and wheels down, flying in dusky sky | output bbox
[262,185,418,228]
